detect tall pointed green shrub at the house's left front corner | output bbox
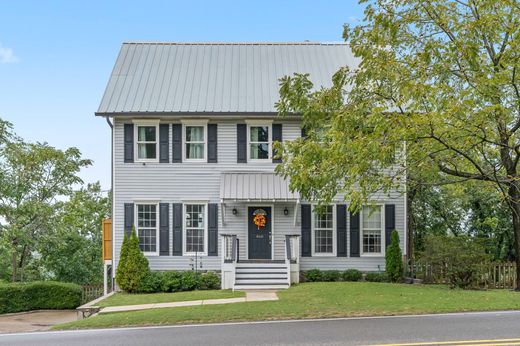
[116,227,150,292]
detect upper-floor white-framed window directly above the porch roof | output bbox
[247,123,272,162]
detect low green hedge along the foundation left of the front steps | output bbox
[137,271,220,293]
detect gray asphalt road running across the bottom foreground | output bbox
[0,311,520,346]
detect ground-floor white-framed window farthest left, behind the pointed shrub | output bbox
[135,203,159,255]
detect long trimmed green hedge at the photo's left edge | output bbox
[0,281,81,314]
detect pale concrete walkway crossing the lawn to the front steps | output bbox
[99,291,278,314]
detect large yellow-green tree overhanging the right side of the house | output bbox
[278,0,520,290]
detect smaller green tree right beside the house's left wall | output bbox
[36,182,111,285]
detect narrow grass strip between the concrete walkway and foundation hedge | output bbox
[96,290,245,307]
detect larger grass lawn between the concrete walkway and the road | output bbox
[54,282,520,329]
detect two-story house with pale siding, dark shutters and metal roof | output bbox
[96,42,406,288]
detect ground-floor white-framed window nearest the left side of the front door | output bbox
[184,202,208,255]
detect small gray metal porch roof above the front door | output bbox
[220,173,300,201]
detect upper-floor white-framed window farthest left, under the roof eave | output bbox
[134,121,159,162]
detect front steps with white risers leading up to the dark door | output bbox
[233,261,289,290]
